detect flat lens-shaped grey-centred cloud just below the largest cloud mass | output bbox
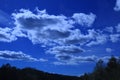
[47,45,84,54]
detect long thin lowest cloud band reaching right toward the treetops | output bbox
[53,55,118,65]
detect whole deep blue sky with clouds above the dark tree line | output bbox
[0,0,120,76]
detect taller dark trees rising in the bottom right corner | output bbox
[81,56,120,80]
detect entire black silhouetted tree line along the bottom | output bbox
[0,56,120,80]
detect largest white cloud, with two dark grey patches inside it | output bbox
[12,9,74,44]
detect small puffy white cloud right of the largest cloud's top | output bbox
[72,13,96,27]
